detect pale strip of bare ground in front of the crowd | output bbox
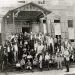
[0,68,75,75]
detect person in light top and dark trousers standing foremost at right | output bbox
[64,47,70,72]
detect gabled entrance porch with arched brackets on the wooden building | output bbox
[1,2,51,40]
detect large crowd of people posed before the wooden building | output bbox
[0,32,74,72]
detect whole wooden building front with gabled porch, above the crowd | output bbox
[1,2,75,42]
